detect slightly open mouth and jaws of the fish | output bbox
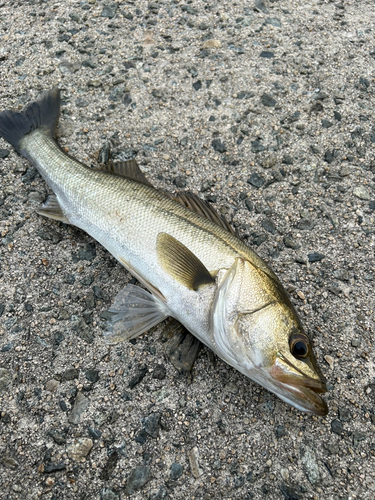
[271,356,328,416]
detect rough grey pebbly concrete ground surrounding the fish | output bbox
[0,0,375,500]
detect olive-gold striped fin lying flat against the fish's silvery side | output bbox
[156,233,215,290]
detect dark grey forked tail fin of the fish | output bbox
[0,87,60,153]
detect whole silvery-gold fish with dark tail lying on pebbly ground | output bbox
[0,87,328,416]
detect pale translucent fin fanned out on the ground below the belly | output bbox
[104,285,169,344]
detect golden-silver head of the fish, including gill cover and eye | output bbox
[212,258,328,415]
